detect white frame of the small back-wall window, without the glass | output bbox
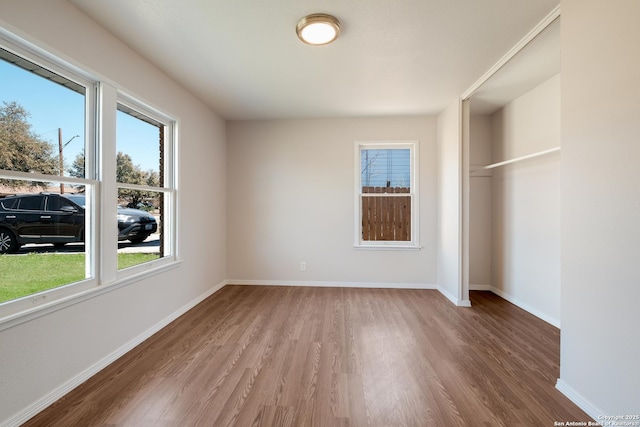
[354,140,420,250]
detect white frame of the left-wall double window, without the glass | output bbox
[0,28,180,331]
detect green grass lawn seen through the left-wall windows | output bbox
[0,253,158,303]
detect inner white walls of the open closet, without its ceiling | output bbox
[469,74,560,327]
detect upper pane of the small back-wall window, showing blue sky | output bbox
[360,148,411,188]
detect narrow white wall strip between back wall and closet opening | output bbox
[437,100,469,305]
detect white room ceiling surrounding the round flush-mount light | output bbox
[70,0,559,119]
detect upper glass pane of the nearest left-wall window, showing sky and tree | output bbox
[0,49,85,181]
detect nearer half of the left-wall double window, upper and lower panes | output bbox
[0,43,96,305]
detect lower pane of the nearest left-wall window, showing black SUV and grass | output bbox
[0,182,89,302]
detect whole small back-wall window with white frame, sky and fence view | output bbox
[355,141,419,248]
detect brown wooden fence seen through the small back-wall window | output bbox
[361,187,411,242]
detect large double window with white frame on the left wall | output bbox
[0,36,176,321]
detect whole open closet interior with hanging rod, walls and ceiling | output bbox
[463,16,561,327]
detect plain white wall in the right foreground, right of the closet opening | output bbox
[558,0,640,417]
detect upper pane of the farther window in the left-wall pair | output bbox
[116,105,164,187]
